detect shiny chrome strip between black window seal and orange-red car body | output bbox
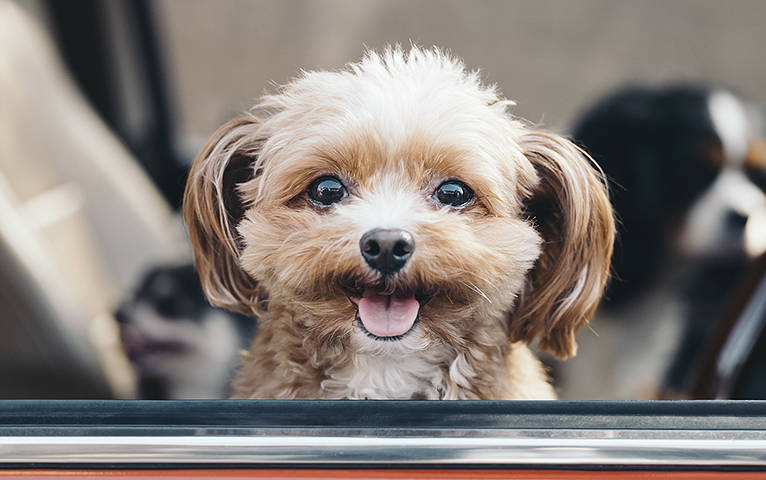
[0,431,766,467]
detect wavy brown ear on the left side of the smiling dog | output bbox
[183,117,266,315]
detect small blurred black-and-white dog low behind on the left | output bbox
[115,264,255,400]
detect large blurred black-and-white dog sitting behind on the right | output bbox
[563,83,766,398]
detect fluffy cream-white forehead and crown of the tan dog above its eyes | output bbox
[261,51,536,198]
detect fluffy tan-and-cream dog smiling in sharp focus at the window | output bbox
[183,47,614,399]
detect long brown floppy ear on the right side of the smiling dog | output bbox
[511,132,614,358]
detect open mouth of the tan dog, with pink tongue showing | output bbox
[349,287,430,340]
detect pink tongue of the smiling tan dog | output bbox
[358,290,420,337]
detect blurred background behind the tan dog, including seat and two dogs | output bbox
[0,0,766,399]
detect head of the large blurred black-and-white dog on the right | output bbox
[574,84,766,308]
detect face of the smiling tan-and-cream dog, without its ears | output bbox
[238,100,541,347]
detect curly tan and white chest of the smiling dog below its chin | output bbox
[233,306,555,400]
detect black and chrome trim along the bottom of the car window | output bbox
[0,401,766,470]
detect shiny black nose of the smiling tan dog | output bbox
[359,228,415,273]
